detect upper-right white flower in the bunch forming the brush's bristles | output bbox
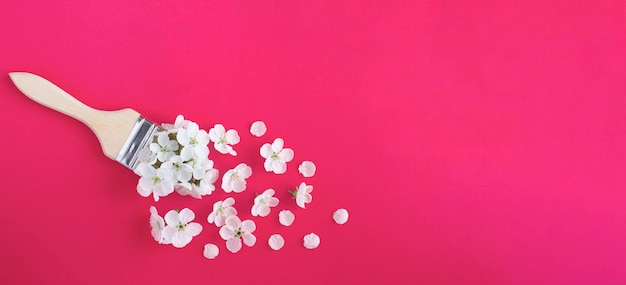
[176,122,209,161]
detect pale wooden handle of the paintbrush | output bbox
[9,72,140,159]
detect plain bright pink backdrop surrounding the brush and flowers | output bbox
[0,0,626,284]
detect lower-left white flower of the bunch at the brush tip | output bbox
[137,163,176,201]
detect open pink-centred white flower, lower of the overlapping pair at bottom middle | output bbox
[220,216,256,253]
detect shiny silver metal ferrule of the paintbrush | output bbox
[115,116,159,171]
